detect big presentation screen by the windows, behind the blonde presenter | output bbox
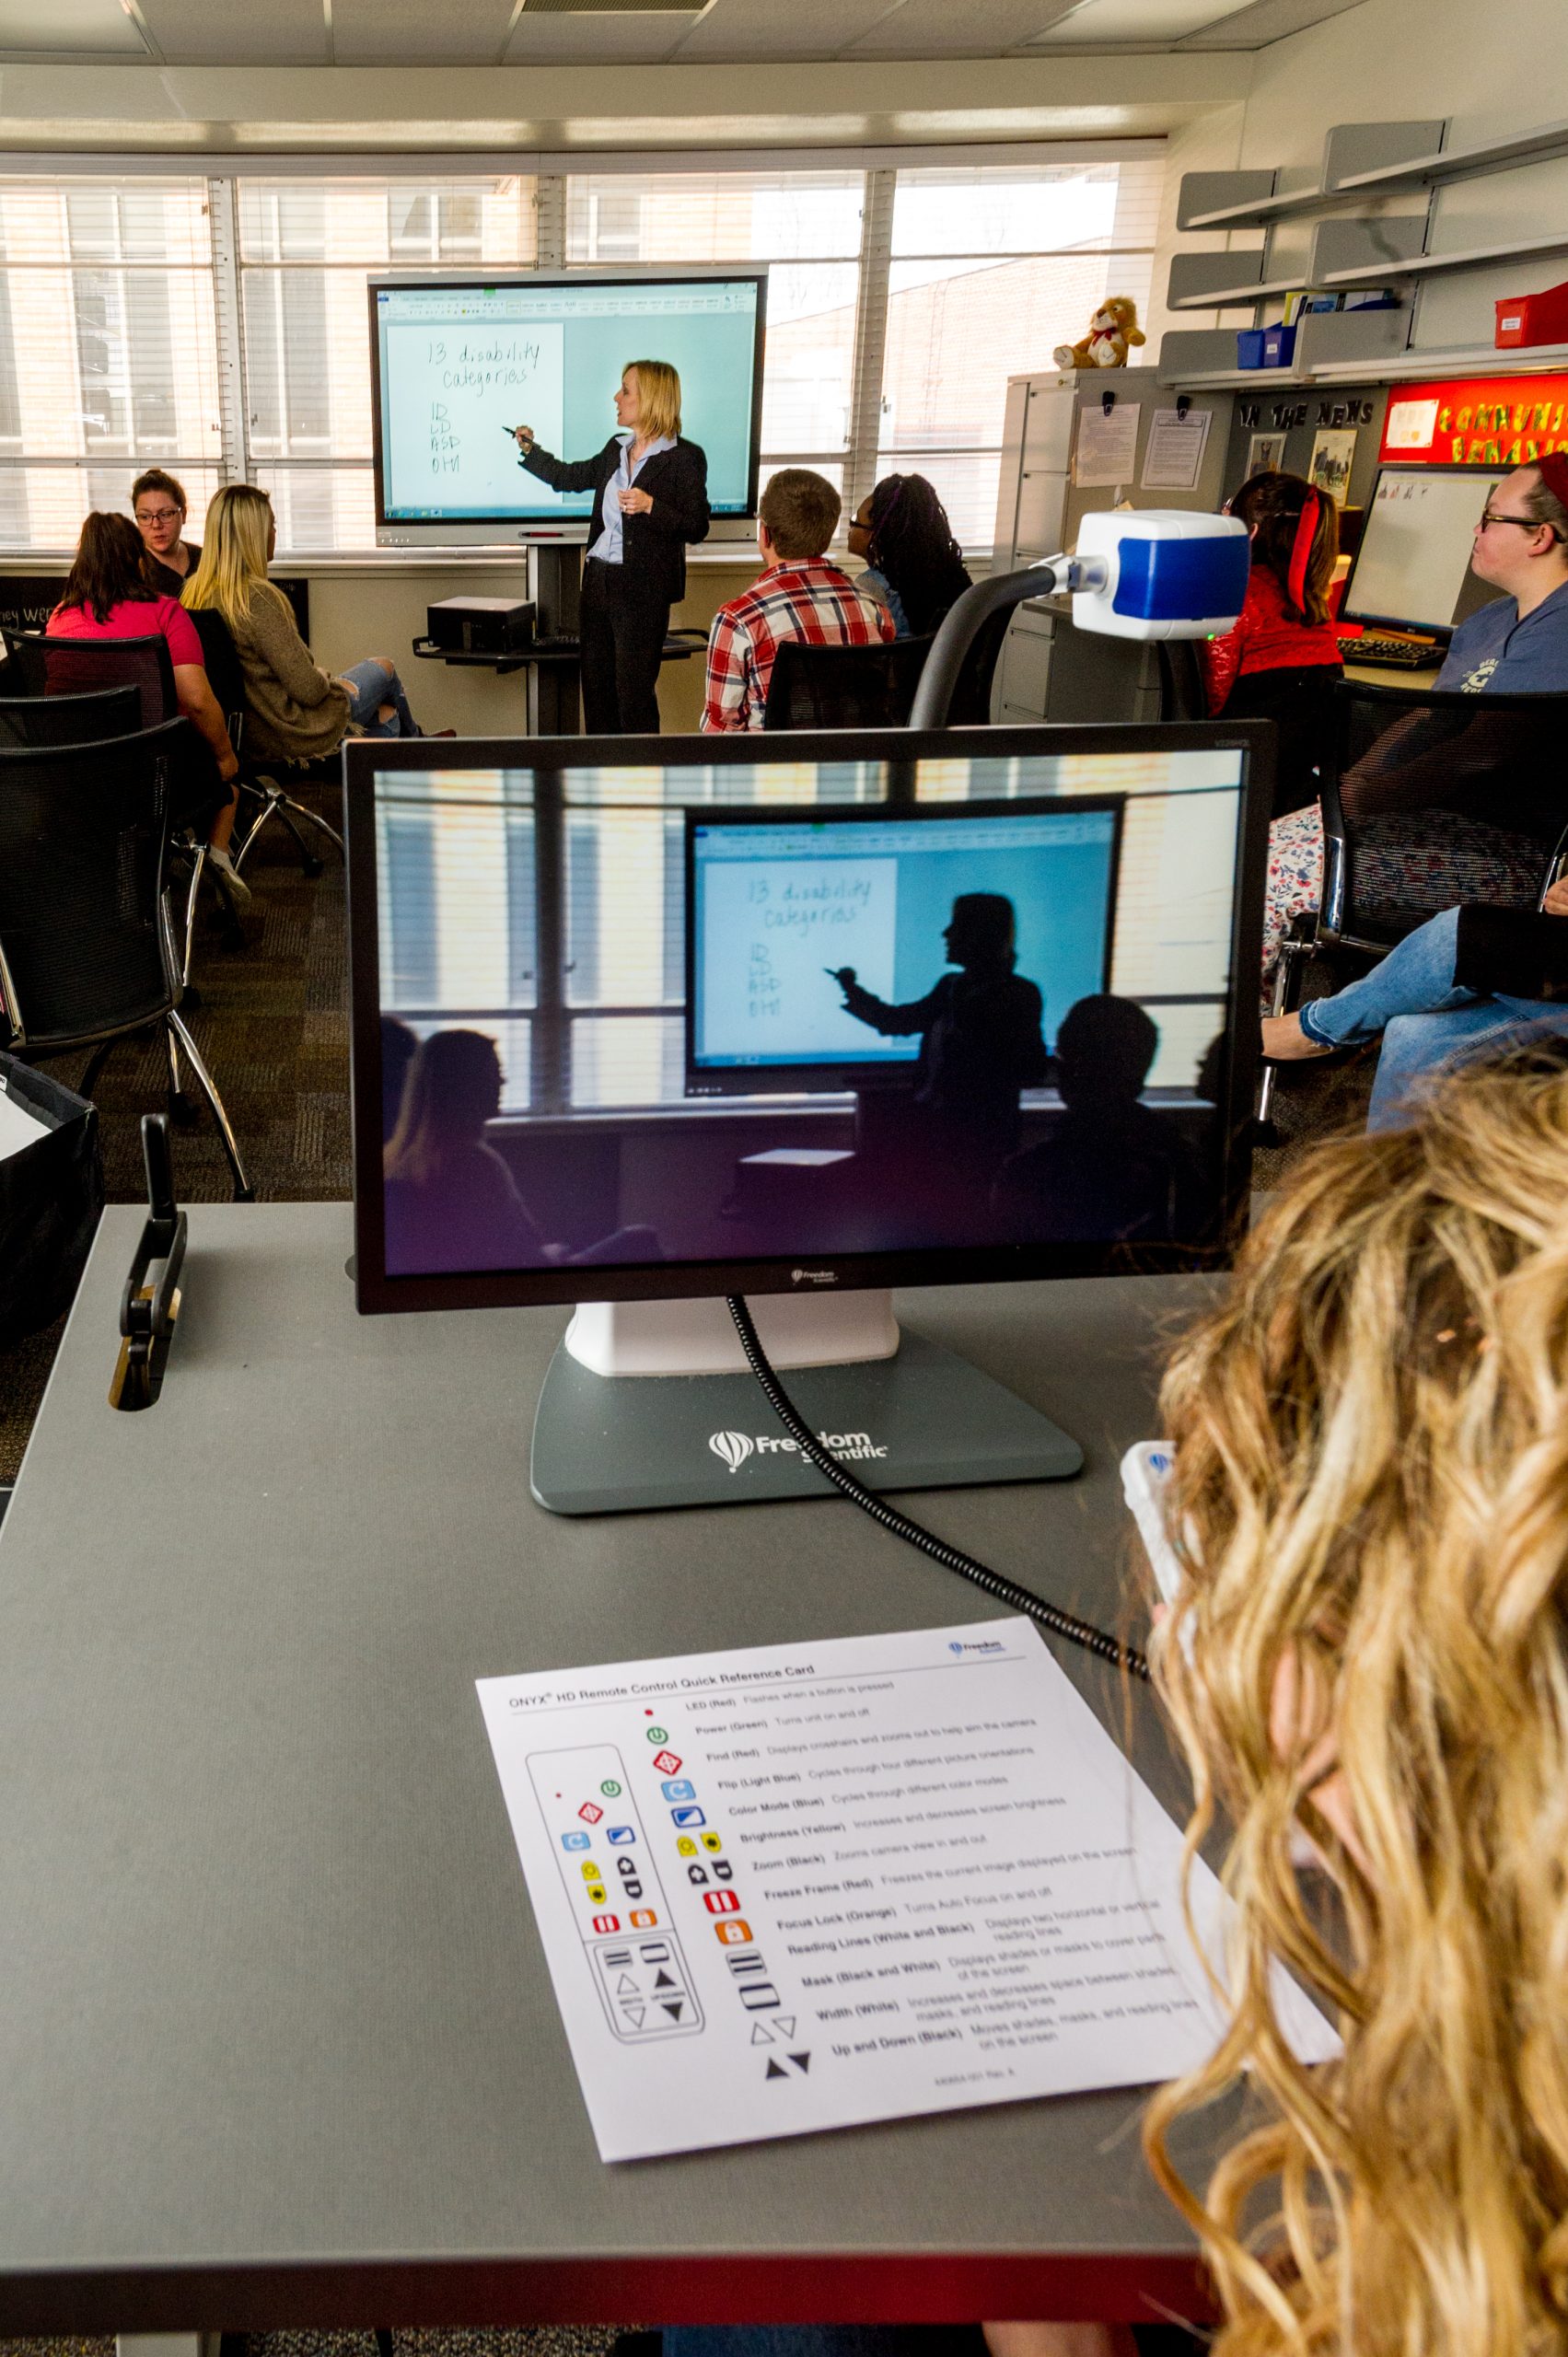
[370,269,769,544]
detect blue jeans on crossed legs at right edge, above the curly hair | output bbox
[1302,908,1568,1129]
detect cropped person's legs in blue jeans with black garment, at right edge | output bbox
[1264,877,1568,1129]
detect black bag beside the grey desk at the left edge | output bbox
[0,1056,104,1348]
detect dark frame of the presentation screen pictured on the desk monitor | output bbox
[684,795,1127,1106]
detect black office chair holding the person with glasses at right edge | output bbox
[1257,679,1568,1124]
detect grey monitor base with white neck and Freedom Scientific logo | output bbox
[530,1292,1082,1514]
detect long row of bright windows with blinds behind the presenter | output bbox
[0,142,1163,559]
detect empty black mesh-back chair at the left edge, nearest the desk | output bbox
[0,721,255,1202]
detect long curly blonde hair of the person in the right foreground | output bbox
[1146,1063,1568,2357]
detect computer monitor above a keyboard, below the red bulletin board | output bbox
[1342,467,1502,634]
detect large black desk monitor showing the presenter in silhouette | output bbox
[346,724,1271,1310]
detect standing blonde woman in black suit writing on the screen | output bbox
[517,361,707,736]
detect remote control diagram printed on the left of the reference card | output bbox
[528,1744,703,2046]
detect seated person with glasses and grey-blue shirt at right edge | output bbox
[1264,450,1568,973]
